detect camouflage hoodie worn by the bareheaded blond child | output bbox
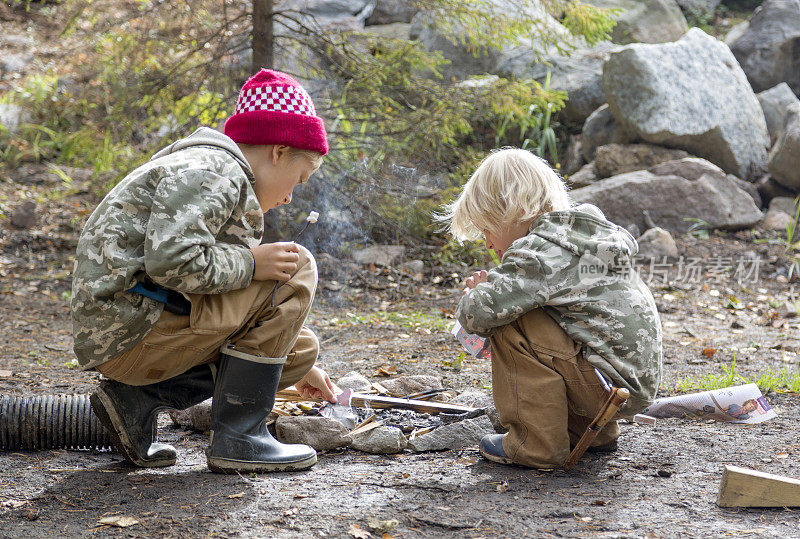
[456,204,662,414]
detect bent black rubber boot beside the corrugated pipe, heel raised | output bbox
[90,365,214,468]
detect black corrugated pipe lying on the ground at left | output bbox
[0,395,112,450]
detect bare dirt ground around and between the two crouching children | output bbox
[0,212,800,537]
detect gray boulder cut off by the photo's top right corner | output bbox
[731,0,800,95]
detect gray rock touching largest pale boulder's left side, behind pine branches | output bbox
[497,42,622,124]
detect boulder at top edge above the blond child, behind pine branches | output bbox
[411,0,574,80]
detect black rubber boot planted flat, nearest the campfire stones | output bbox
[206,348,317,473]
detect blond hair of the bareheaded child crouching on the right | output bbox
[444,148,570,241]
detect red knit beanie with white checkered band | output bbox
[225,69,328,155]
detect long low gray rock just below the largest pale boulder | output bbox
[570,170,762,234]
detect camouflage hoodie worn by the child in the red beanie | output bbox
[71,127,263,370]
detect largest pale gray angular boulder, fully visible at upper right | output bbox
[603,28,768,181]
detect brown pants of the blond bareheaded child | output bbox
[491,309,619,468]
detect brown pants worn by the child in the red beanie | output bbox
[97,246,319,389]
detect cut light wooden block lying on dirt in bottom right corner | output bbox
[717,466,800,507]
